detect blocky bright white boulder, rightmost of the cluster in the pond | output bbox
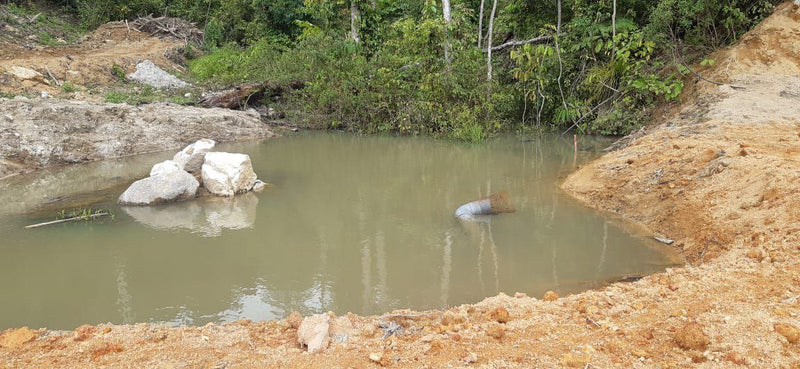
[202,152,257,196]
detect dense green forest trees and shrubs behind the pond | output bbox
[28,0,779,141]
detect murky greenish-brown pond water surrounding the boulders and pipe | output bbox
[0,133,678,329]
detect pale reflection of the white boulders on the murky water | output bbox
[122,192,258,237]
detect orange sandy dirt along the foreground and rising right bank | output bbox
[0,2,800,368]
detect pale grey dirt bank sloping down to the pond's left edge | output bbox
[0,97,275,178]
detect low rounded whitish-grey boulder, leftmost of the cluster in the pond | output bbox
[117,170,200,205]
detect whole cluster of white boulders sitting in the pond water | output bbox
[118,139,265,206]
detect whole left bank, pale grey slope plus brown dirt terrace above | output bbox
[0,22,275,179]
